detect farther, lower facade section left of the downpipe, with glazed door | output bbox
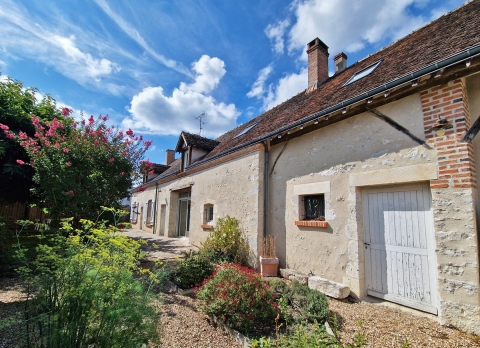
[132,147,264,264]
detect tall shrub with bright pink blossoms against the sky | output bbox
[0,108,151,221]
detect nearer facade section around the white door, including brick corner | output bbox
[268,75,480,334]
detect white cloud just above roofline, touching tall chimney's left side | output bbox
[263,68,308,110]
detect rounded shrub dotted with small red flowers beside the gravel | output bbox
[197,264,278,333]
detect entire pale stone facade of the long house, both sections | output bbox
[132,74,480,334]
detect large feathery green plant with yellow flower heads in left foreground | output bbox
[15,216,158,348]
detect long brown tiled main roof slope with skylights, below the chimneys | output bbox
[206,0,480,159]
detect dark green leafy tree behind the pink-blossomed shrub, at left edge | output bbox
[0,74,64,202]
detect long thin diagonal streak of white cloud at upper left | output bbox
[94,0,193,77]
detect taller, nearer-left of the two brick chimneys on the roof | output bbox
[307,37,329,90]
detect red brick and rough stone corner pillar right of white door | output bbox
[421,79,480,334]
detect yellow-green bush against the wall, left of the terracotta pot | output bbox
[202,215,250,266]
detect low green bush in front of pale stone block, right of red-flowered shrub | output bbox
[284,281,330,323]
